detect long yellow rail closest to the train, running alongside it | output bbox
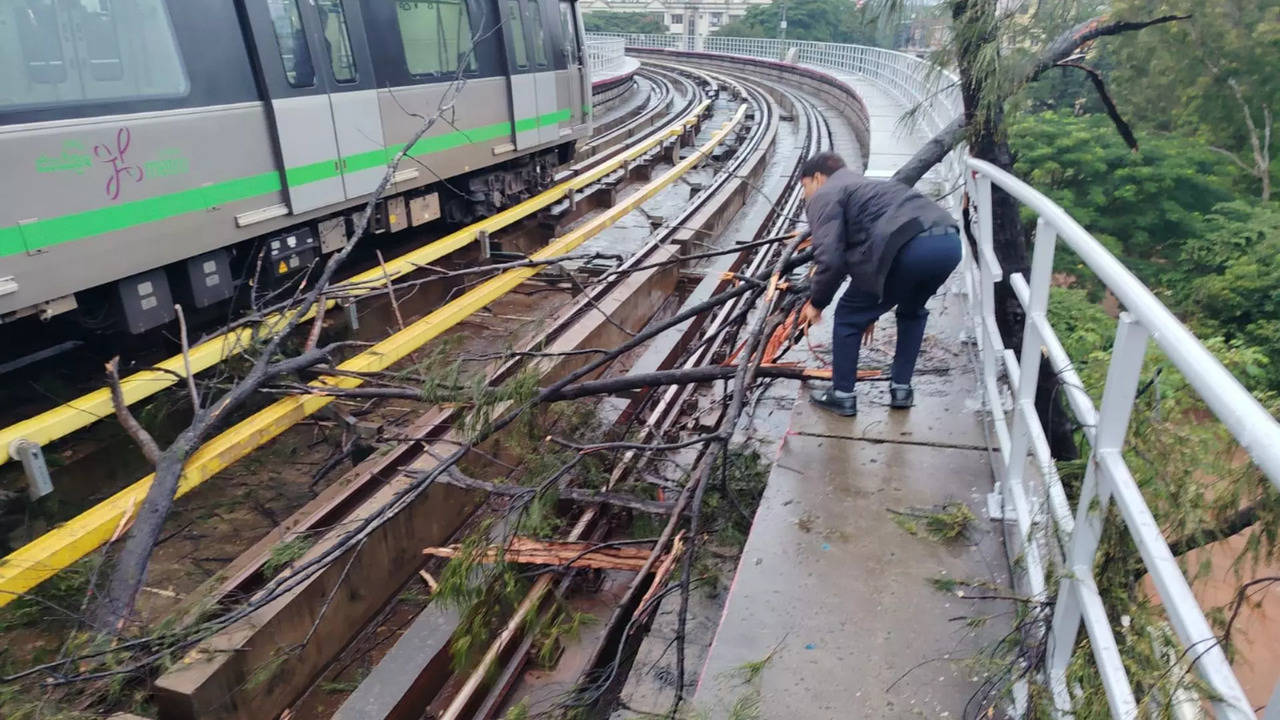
[0,100,710,465]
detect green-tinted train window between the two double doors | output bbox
[396,0,476,76]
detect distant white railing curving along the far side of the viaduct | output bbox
[588,33,964,182]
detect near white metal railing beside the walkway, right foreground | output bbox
[965,158,1280,719]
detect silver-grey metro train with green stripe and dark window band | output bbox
[0,0,591,333]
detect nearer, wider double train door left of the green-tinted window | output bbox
[244,0,387,214]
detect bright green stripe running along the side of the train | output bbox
[0,109,572,258]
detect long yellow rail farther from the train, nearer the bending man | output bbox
[0,105,746,606]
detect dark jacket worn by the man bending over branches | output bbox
[805,168,956,310]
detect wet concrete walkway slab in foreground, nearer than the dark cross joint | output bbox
[694,427,1005,719]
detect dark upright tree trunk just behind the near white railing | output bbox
[951,0,1078,459]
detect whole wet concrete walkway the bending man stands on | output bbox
[692,71,1010,720]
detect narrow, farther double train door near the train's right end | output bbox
[502,0,561,150]
